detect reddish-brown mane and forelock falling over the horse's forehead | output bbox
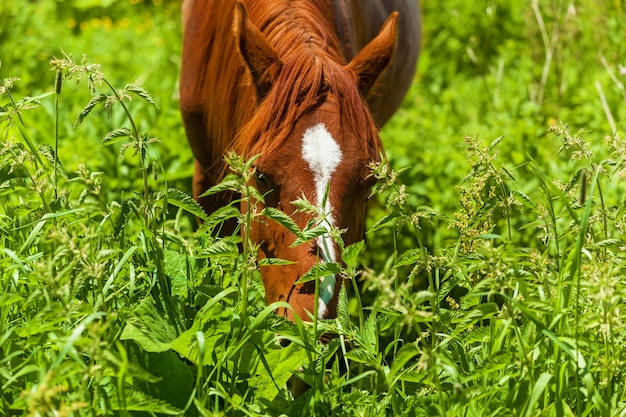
[233,0,382,167]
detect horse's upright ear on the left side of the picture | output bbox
[235,0,282,101]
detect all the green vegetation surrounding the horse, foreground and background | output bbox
[0,0,626,417]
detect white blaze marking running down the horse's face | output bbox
[302,123,342,318]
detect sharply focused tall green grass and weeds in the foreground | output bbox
[0,56,626,416]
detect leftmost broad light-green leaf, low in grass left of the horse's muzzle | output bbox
[120,298,177,352]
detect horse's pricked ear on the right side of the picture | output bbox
[348,12,398,97]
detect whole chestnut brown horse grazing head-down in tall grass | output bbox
[180,0,421,319]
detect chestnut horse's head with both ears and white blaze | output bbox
[234,2,398,319]
